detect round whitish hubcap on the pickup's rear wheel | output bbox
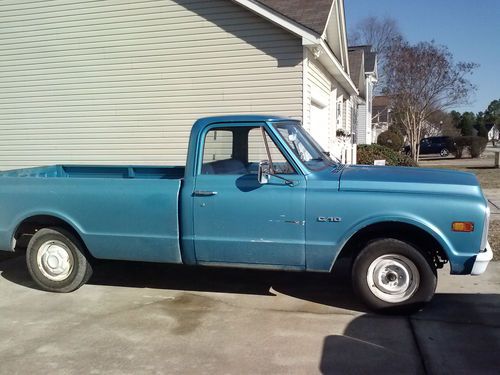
[36,240,74,281]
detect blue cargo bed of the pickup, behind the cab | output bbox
[0,165,184,263]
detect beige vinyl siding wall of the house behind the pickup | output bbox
[0,0,303,169]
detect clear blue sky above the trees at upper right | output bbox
[345,0,500,112]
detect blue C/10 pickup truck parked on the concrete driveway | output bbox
[0,116,492,311]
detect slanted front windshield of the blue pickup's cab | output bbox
[273,122,337,171]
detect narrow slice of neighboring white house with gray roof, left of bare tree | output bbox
[349,46,377,145]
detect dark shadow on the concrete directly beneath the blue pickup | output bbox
[0,256,365,312]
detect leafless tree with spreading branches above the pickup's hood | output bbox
[385,42,476,161]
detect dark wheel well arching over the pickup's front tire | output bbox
[338,222,448,268]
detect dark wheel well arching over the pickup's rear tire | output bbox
[12,215,88,253]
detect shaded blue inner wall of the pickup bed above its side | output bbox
[0,165,184,179]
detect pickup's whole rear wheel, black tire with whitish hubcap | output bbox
[26,228,92,293]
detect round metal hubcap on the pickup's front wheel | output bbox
[366,254,420,303]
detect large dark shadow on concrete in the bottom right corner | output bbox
[319,293,500,374]
